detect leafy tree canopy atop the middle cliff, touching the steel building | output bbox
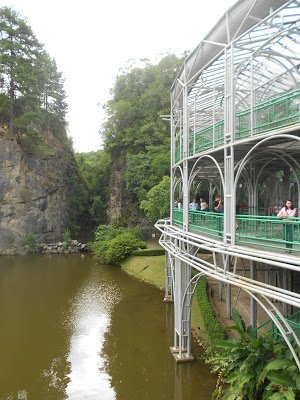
[102,55,182,212]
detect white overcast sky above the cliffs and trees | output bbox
[0,0,235,152]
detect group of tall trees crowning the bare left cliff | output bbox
[0,7,67,144]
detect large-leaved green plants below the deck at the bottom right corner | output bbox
[207,310,300,400]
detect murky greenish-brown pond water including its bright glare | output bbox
[0,255,215,400]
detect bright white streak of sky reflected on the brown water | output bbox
[66,271,118,400]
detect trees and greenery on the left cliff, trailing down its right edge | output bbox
[0,7,89,238]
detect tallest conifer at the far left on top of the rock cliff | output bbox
[0,7,43,137]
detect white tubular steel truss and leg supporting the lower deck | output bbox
[155,220,300,369]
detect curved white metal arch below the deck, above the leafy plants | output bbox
[244,289,300,370]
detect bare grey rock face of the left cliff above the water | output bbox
[0,137,78,254]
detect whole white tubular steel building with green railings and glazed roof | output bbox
[156,0,300,369]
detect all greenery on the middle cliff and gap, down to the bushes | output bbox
[76,55,182,230]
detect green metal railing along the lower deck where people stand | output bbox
[173,208,300,253]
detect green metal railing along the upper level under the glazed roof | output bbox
[175,89,300,162]
